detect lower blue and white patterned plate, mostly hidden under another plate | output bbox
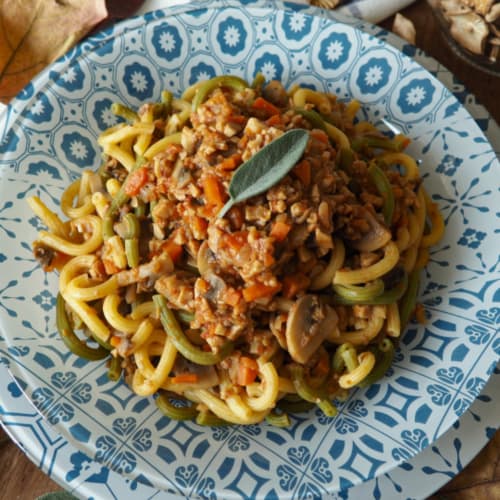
[0,358,500,500]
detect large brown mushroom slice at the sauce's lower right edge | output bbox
[285,295,338,364]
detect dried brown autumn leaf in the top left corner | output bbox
[0,0,107,103]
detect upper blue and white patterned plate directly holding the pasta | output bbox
[0,0,500,498]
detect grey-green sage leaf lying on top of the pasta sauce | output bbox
[219,129,309,217]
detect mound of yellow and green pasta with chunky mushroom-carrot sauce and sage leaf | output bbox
[28,75,444,426]
